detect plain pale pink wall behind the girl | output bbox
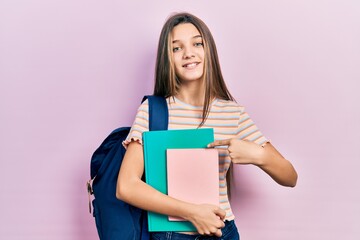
[0,0,360,240]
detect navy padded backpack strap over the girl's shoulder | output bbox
[142,95,169,131]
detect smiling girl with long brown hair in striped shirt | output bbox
[117,13,297,240]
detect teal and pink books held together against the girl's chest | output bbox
[143,128,219,232]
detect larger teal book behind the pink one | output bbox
[143,128,214,232]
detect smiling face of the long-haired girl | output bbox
[171,23,205,83]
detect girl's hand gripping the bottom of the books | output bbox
[187,204,226,237]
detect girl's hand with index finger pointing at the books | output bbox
[208,138,264,165]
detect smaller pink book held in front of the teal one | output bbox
[167,148,219,221]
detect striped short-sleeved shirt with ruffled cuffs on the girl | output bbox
[123,97,268,220]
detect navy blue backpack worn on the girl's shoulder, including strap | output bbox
[87,96,168,240]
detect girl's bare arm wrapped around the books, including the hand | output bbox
[116,142,225,237]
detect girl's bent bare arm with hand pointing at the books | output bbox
[208,138,298,187]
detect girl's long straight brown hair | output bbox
[154,12,234,127]
